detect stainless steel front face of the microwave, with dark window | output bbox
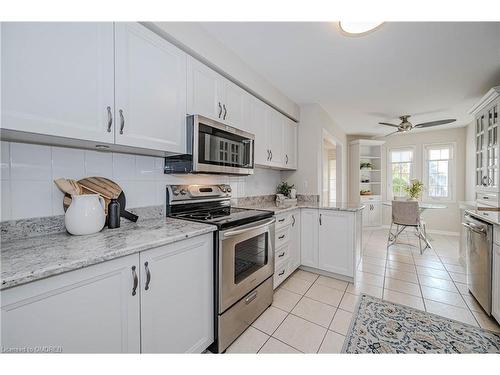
[193,115,254,175]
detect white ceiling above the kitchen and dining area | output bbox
[201,22,500,134]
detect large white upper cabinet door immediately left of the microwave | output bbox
[115,23,186,153]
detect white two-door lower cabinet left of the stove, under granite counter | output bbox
[1,234,214,353]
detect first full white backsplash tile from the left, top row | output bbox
[10,143,52,181]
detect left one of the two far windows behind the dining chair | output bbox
[388,148,414,197]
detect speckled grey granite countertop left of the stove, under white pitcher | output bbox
[0,217,217,289]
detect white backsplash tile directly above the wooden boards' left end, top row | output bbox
[52,147,85,180]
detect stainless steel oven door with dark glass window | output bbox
[219,218,275,314]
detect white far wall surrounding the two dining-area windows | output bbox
[382,128,468,233]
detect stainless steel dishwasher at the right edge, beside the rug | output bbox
[462,214,493,315]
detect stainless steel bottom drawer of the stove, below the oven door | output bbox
[217,277,273,352]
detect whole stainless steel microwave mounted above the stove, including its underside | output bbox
[165,115,255,175]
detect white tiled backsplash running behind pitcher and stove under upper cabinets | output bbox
[0,142,281,221]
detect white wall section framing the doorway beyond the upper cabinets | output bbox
[282,104,347,201]
